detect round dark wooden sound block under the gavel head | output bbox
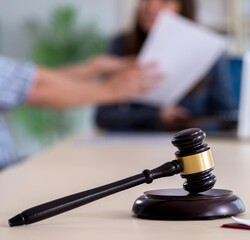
[132,189,245,220]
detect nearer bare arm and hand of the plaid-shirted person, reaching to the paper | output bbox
[26,65,161,108]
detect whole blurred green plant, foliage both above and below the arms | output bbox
[11,6,106,143]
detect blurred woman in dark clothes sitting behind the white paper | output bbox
[96,0,234,131]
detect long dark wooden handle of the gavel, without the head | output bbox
[9,160,182,227]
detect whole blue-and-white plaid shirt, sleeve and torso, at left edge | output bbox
[0,56,35,169]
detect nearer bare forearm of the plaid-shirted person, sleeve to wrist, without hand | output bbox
[27,69,117,108]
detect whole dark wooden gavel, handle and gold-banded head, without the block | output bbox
[9,128,216,227]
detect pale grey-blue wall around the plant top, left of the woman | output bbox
[0,0,121,58]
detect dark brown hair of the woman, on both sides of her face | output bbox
[125,0,196,55]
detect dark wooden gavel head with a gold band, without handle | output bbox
[172,128,216,194]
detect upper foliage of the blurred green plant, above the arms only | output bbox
[27,6,106,67]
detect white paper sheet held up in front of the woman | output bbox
[136,12,227,106]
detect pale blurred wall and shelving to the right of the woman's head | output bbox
[197,0,250,55]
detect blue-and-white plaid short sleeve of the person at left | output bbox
[0,56,35,110]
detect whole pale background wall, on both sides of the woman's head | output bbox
[0,0,250,58]
